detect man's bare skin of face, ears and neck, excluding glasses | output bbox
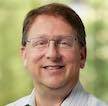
[21,15,86,106]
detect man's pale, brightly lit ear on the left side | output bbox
[20,46,27,67]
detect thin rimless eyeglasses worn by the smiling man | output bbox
[26,36,77,50]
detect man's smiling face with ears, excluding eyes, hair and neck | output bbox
[21,15,86,89]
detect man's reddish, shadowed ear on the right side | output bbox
[80,47,87,68]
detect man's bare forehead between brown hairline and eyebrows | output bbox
[28,15,75,37]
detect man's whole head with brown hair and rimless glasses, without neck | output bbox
[21,3,86,89]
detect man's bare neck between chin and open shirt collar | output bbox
[35,82,77,106]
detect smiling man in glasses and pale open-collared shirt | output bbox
[7,3,107,106]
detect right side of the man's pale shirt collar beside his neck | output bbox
[61,81,88,106]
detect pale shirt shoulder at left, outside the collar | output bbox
[6,95,30,106]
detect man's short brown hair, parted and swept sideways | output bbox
[22,3,86,47]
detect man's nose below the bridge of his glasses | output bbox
[45,41,61,61]
